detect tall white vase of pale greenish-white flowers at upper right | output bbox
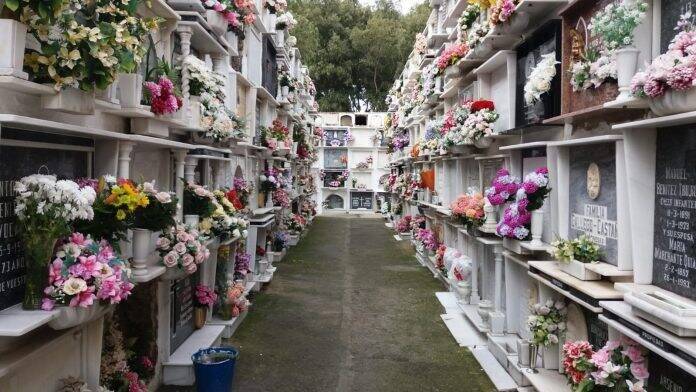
[589,0,648,100]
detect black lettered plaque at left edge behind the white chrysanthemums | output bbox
[0,128,91,310]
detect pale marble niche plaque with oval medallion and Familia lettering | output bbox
[568,143,618,265]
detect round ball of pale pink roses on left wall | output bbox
[156,224,210,275]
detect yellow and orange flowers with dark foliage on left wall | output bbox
[74,176,150,250]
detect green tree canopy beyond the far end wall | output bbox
[289,0,430,111]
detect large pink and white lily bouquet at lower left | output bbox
[41,233,134,310]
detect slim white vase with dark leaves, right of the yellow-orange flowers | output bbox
[132,182,177,276]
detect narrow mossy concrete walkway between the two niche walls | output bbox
[229,217,494,392]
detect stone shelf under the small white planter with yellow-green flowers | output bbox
[528,261,623,313]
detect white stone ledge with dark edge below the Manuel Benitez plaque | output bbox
[599,301,696,377]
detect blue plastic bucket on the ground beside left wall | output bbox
[191,347,239,392]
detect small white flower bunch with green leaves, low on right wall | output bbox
[527,299,568,346]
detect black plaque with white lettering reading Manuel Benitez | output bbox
[653,126,696,299]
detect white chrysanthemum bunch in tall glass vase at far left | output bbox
[14,174,96,310]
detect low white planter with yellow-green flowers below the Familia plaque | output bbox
[551,234,602,280]
